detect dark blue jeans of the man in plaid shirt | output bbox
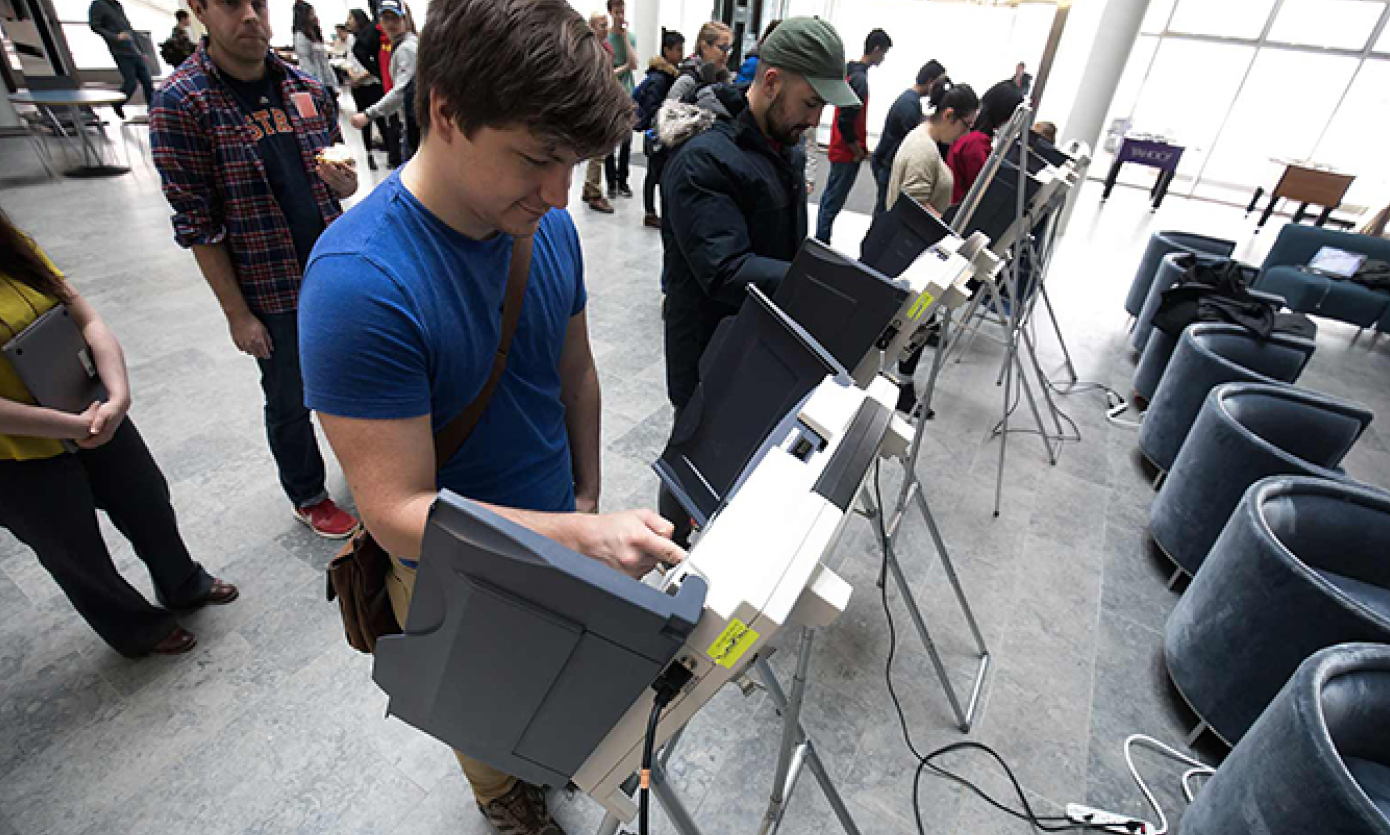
[256,311,328,507]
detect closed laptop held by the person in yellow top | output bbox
[0,304,107,414]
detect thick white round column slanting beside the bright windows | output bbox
[1061,0,1150,150]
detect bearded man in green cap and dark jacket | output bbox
[657,18,859,542]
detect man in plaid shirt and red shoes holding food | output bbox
[150,0,357,539]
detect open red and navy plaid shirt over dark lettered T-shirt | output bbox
[150,44,342,314]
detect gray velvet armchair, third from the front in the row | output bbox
[1148,383,1373,574]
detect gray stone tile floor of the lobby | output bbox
[0,118,1390,835]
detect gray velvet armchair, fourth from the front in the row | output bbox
[1138,324,1314,472]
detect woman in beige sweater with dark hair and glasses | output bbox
[887,79,980,214]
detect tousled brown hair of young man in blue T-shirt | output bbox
[416,0,632,158]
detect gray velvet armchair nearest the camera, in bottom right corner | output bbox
[1176,643,1390,835]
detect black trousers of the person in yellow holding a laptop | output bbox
[0,420,213,656]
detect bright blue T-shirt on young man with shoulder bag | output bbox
[299,174,587,511]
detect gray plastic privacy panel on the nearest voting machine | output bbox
[373,490,708,786]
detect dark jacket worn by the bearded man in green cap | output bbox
[657,85,806,408]
